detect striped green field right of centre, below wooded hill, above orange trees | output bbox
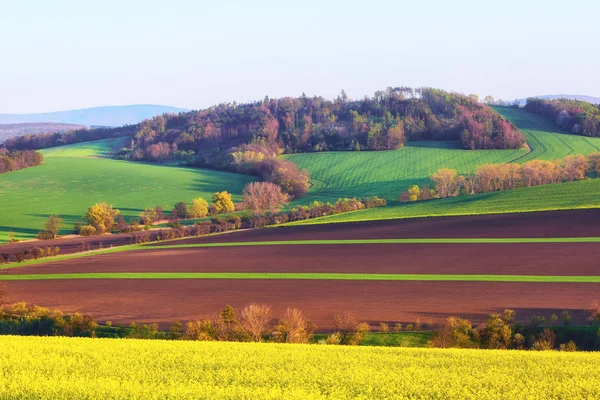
[286,108,600,204]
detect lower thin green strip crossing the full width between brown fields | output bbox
[0,272,600,283]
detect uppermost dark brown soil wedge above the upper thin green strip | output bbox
[148,209,600,246]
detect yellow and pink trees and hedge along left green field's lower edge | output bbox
[0,182,387,264]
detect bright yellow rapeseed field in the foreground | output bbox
[0,336,600,399]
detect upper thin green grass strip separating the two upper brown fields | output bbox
[139,237,600,250]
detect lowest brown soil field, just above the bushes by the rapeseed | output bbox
[7,280,600,330]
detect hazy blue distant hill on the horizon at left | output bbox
[0,104,188,126]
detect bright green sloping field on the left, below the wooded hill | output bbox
[0,140,252,243]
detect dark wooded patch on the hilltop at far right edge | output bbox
[525,98,600,137]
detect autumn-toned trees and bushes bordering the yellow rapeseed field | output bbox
[0,290,600,351]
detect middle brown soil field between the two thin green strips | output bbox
[0,243,600,275]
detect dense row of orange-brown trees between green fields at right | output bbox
[400,153,600,202]
